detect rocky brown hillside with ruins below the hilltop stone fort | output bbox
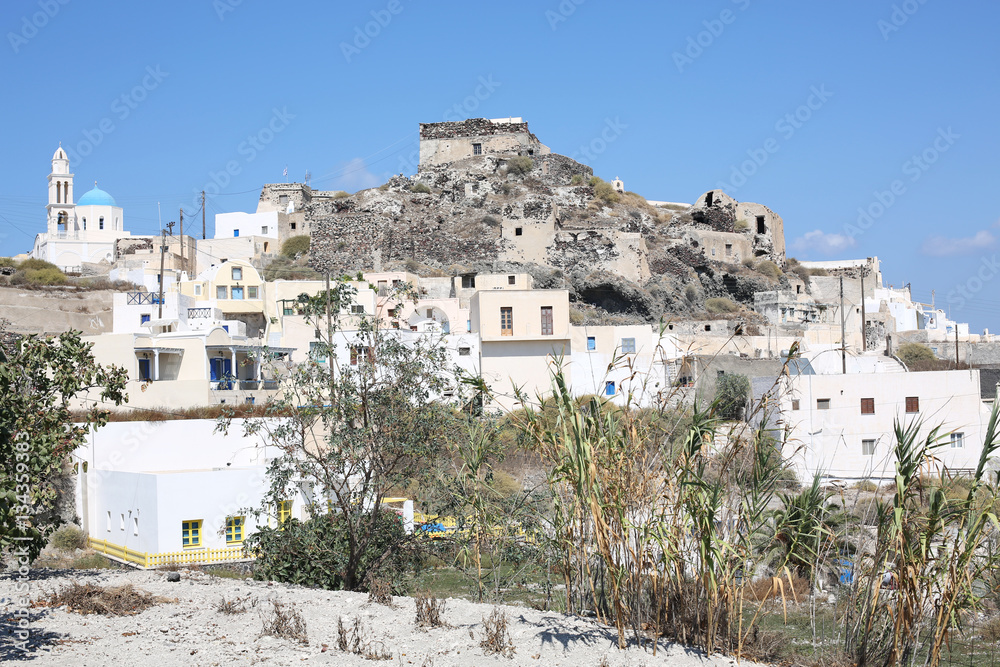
[305,154,788,322]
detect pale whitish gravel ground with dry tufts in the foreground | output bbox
[0,570,764,667]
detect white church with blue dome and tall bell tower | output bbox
[30,144,131,271]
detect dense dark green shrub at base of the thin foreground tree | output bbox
[244,509,407,590]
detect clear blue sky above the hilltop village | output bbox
[0,0,1000,331]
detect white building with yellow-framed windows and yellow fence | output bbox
[73,419,280,565]
